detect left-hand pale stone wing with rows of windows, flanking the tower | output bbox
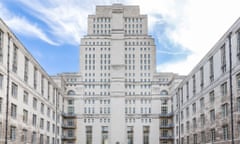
[0,19,63,144]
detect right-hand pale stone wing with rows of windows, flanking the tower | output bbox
[173,19,240,144]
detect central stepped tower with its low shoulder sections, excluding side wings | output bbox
[59,4,181,144]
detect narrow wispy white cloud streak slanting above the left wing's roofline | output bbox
[0,3,57,45]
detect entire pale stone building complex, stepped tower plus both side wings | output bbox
[0,4,240,144]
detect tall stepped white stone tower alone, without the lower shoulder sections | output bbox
[80,4,159,144]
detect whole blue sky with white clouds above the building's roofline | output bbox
[0,0,240,75]
